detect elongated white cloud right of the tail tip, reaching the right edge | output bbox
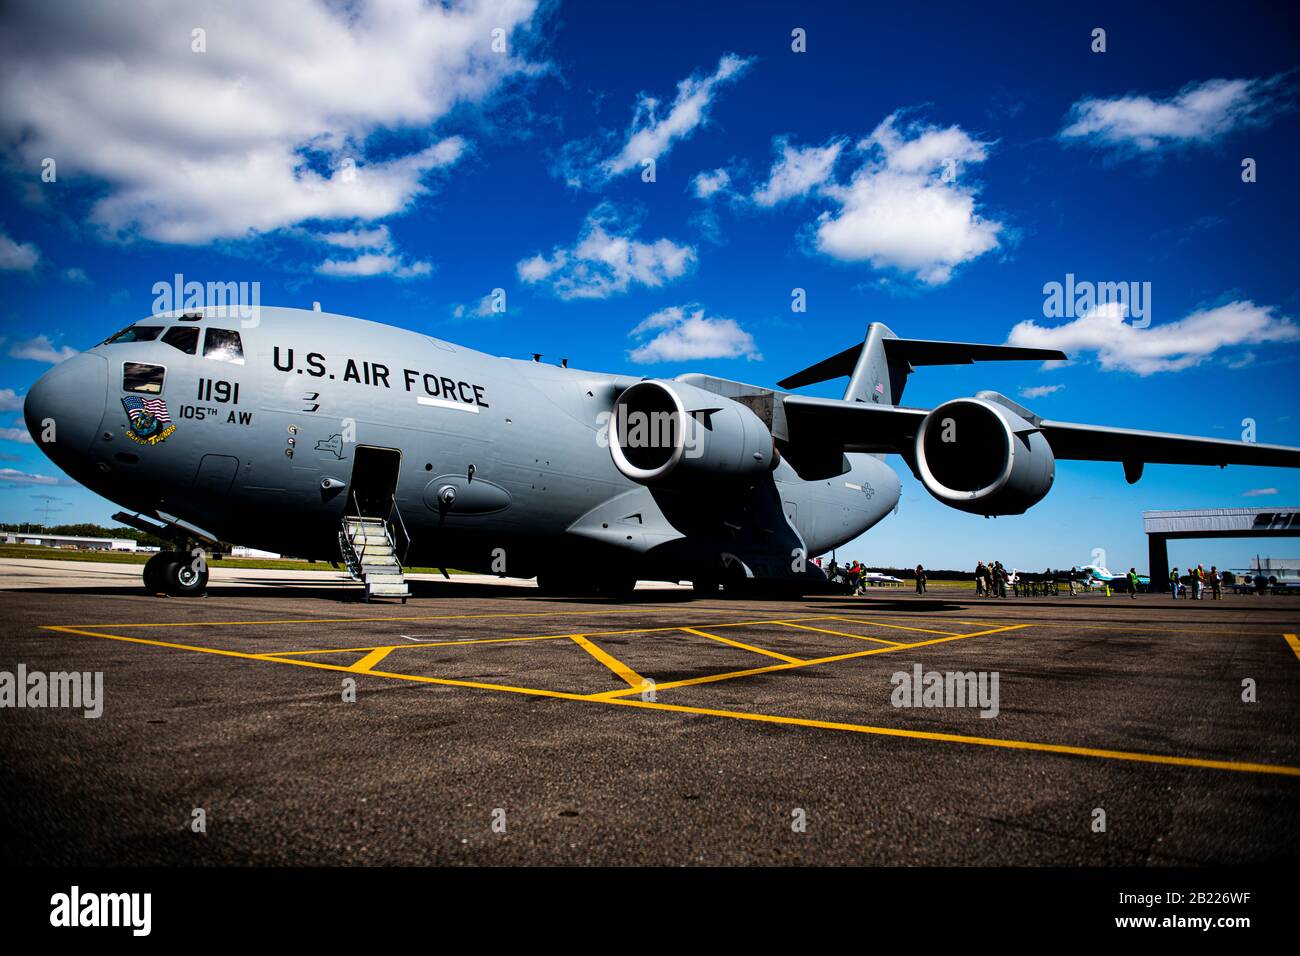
[1006,300,1300,376]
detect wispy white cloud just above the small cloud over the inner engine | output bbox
[516,203,696,299]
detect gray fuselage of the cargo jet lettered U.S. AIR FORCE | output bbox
[25,307,900,580]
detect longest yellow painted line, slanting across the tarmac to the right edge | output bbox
[44,624,1300,778]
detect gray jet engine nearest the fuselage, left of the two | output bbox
[608,380,777,485]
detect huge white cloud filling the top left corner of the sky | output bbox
[0,0,538,243]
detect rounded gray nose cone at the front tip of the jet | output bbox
[22,352,108,463]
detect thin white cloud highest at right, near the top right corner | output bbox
[1058,74,1287,152]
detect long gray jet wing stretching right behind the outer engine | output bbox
[783,394,1300,468]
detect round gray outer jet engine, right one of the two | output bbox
[915,398,1056,515]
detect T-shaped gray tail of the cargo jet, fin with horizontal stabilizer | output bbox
[777,323,1066,405]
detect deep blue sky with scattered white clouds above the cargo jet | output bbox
[0,0,1300,568]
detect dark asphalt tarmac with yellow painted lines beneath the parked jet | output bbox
[0,562,1300,865]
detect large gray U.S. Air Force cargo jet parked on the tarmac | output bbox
[23,307,1300,601]
